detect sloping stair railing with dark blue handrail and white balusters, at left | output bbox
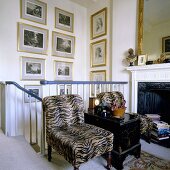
[5,81,42,152]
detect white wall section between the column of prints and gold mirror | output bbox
[112,0,138,111]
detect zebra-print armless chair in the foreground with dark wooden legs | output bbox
[42,95,113,170]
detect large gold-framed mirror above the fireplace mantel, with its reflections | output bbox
[137,0,170,60]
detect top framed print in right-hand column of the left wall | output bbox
[55,8,74,32]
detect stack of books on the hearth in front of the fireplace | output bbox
[151,121,170,140]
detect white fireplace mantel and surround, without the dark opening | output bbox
[126,63,170,112]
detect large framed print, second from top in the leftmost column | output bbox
[18,23,48,54]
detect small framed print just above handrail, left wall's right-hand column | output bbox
[54,61,73,81]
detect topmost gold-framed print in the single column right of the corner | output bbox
[91,8,107,39]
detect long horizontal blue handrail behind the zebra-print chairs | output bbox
[40,80,128,85]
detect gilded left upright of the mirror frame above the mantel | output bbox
[138,0,144,55]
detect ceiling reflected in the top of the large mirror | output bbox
[144,0,170,26]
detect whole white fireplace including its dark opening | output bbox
[126,63,170,124]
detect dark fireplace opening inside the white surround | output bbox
[137,82,170,124]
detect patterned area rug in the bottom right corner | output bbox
[124,151,170,170]
